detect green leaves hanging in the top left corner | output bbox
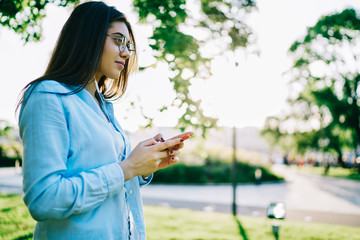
[0,0,80,43]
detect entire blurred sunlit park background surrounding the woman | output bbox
[0,0,360,239]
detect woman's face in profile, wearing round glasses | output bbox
[95,22,130,80]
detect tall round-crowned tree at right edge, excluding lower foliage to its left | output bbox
[290,9,360,155]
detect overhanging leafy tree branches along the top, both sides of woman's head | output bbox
[0,0,255,134]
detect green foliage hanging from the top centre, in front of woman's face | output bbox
[133,0,254,135]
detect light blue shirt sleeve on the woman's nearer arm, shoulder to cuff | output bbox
[19,83,124,221]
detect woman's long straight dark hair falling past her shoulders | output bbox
[16,2,137,110]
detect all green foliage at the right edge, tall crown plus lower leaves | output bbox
[262,9,360,164]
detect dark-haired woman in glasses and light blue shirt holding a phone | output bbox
[19,2,192,240]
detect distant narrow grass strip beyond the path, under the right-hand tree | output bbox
[292,166,360,181]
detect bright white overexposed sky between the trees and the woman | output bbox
[0,0,360,131]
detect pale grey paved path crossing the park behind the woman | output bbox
[0,166,360,226]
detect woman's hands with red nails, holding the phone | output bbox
[119,134,184,181]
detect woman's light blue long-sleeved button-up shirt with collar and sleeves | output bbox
[19,80,151,240]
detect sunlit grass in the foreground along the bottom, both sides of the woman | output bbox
[0,194,360,240]
